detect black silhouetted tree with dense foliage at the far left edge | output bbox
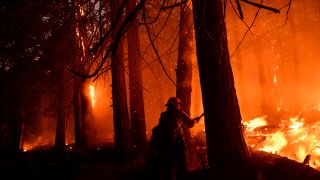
[0,1,53,151]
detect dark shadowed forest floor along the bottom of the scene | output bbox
[0,145,320,180]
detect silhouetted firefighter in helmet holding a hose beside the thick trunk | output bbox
[151,97,201,180]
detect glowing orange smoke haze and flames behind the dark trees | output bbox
[23,0,320,172]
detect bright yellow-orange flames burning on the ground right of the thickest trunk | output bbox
[243,105,320,170]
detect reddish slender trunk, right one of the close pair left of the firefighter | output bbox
[127,0,147,151]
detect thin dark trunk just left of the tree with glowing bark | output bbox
[53,26,74,150]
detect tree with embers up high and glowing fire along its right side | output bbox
[71,1,96,147]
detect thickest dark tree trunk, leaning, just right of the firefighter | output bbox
[193,0,251,179]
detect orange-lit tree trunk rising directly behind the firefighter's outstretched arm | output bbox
[176,1,193,147]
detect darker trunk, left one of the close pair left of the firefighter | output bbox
[110,1,132,160]
